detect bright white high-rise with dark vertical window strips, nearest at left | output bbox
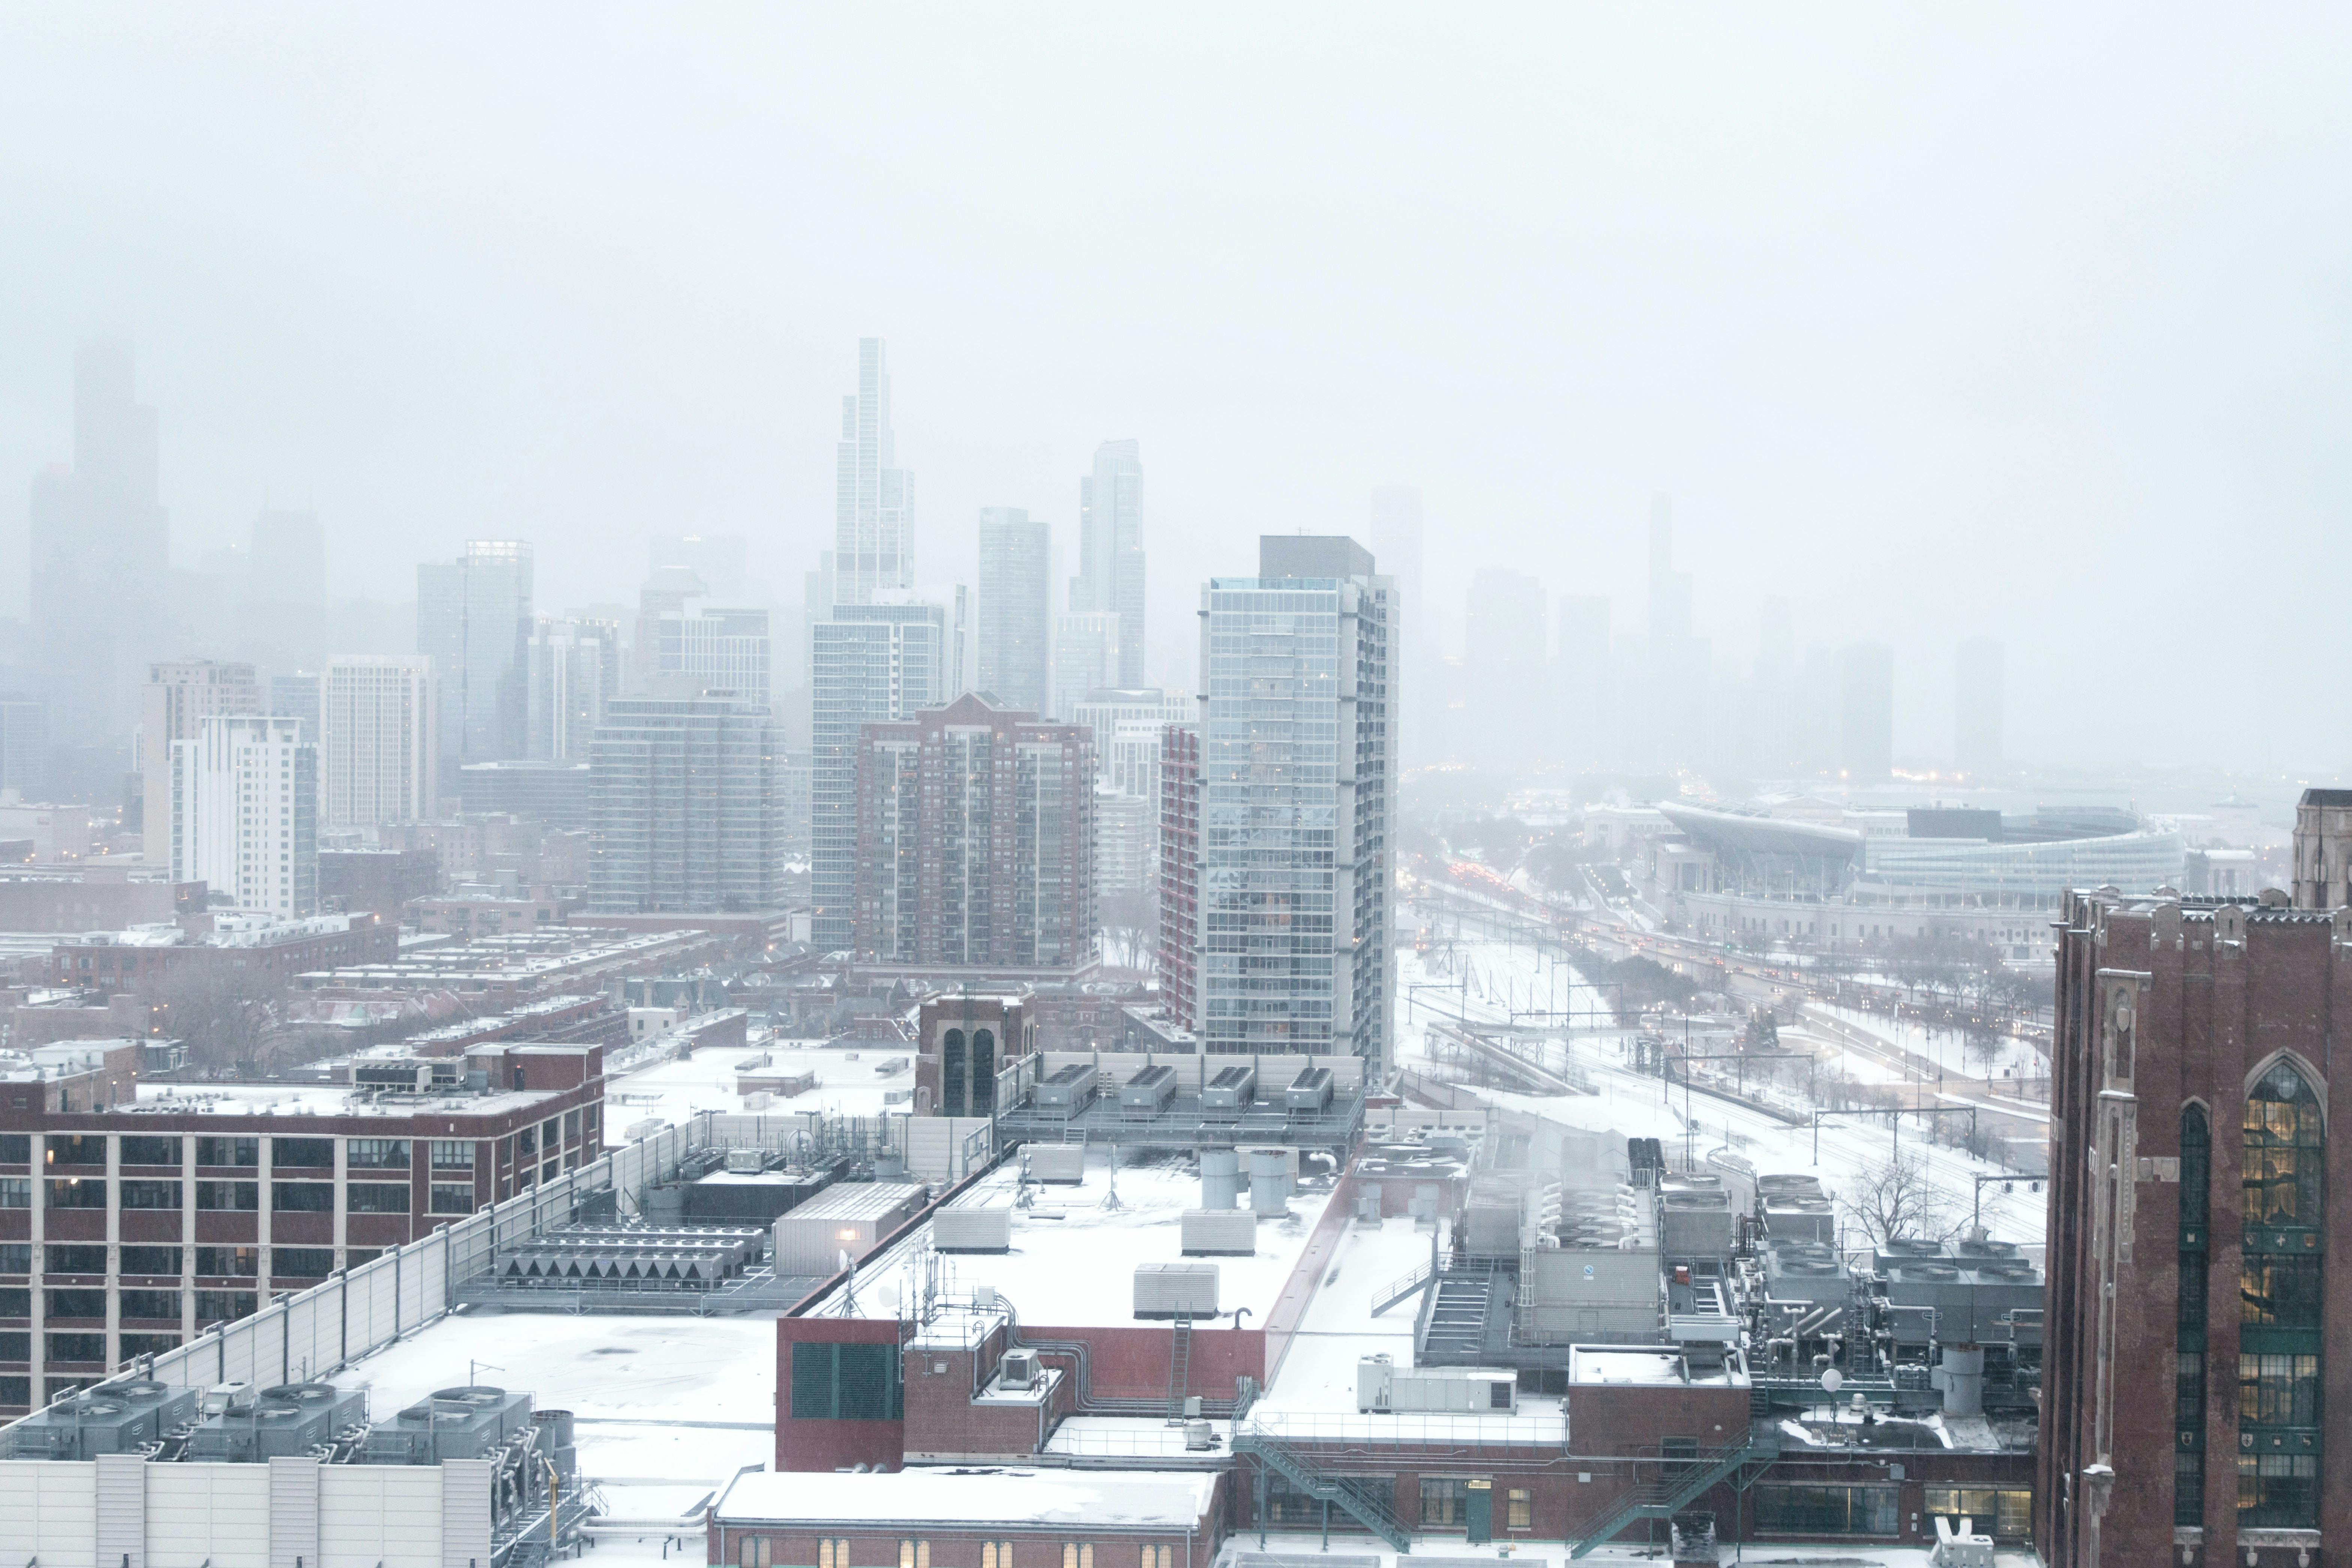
[172,717,318,919]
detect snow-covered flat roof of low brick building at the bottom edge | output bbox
[717,1467,1216,1531]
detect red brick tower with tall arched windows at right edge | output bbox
[2034,790,2352,1568]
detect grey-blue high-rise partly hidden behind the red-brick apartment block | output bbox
[809,602,948,952]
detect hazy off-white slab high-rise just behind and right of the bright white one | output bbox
[318,653,440,828]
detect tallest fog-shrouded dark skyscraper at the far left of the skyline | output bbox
[31,343,169,752]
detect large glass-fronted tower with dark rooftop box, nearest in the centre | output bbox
[1197,534,1397,1074]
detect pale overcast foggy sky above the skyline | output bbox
[0,5,2352,769]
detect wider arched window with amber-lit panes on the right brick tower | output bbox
[2237,1060,2326,1531]
